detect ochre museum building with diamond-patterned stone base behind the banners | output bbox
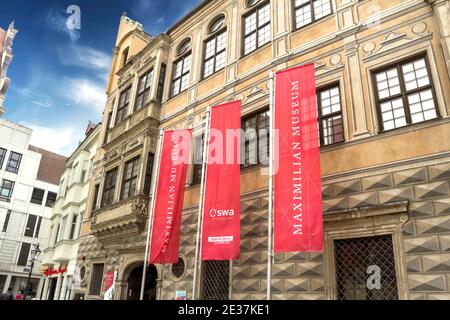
[78,0,450,300]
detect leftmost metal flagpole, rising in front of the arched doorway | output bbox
[140,129,164,300]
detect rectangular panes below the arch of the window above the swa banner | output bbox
[203,30,227,78]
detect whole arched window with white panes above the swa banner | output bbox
[203,14,227,78]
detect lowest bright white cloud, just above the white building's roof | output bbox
[21,122,84,156]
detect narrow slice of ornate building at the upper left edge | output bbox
[0,23,17,117]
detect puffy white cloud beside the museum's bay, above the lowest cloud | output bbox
[64,78,106,114]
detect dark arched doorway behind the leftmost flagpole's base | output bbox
[127,265,158,300]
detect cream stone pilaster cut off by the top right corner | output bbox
[425,0,450,78]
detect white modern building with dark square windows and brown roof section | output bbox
[0,119,66,296]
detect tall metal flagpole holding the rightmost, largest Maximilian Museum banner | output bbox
[267,71,275,300]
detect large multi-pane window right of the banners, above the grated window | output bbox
[374,57,439,131]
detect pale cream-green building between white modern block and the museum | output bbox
[41,122,101,300]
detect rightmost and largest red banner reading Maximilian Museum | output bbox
[274,64,323,252]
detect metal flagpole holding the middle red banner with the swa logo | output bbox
[192,107,211,300]
